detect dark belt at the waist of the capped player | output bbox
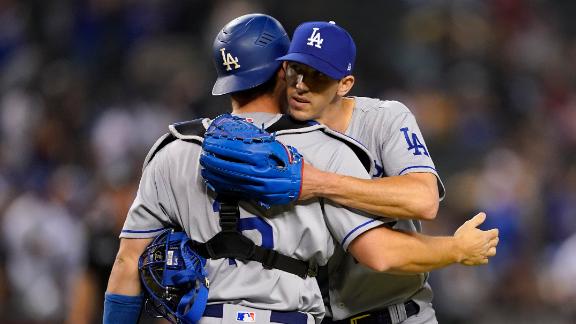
[322,300,420,324]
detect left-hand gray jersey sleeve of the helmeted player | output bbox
[120,147,171,238]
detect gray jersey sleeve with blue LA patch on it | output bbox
[380,102,445,198]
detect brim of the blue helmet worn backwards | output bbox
[212,62,281,96]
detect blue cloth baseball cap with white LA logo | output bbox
[277,21,356,80]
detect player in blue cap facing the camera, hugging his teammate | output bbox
[201,22,498,323]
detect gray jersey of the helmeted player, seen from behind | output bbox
[120,113,381,321]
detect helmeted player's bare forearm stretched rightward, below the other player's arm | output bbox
[349,228,462,274]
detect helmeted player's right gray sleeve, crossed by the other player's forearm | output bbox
[323,145,393,250]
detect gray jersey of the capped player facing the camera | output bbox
[329,97,444,319]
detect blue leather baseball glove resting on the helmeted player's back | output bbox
[200,114,302,206]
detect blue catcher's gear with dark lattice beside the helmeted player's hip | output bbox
[138,229,209,324]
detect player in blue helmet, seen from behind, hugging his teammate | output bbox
[105,15,500,323]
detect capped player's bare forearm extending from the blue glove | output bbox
[301,165,438,220]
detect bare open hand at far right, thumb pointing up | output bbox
[454,213,499,266]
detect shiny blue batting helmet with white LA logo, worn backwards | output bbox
[212,14,290,95]
